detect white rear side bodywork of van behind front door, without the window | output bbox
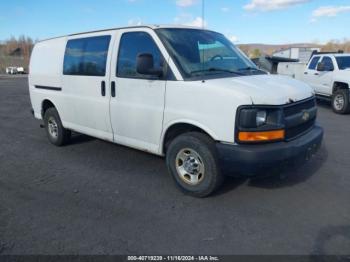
[29,31,114,141]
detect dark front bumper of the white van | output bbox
[216,125,323,176]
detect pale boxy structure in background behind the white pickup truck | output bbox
[272,47,321,63]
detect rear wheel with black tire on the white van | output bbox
[44,107,71,146]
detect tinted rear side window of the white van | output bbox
[63,36,111,76]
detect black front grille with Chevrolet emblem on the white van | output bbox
[283,98,317,141]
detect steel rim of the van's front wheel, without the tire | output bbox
[175,148,205,186]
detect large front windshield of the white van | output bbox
[156,28,266,80]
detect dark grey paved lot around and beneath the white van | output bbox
[0,76,350,255]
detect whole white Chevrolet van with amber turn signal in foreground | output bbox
[29,26,323,197]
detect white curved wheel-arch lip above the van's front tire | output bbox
[161,120,217,155]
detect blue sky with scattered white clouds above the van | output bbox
[0,0,350,44]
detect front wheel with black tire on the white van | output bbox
[166,132,224,197]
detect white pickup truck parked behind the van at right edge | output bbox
[277,53,350,114]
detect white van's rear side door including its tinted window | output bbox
[62,31,115,141]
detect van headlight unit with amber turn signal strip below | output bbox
[236,106,285,143]
